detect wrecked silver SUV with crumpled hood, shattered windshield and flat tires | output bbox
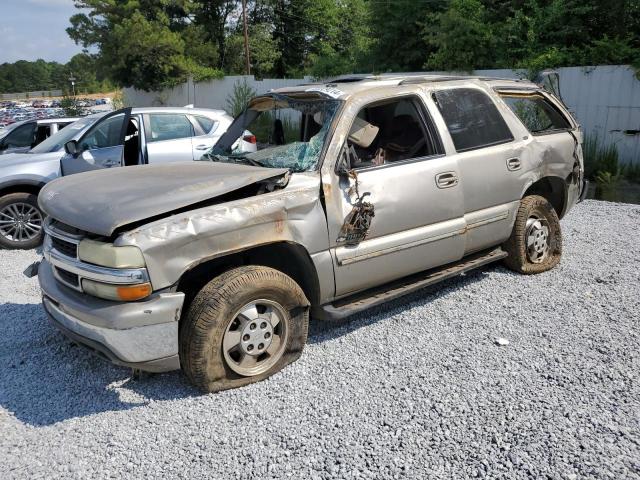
[33,76,585,391]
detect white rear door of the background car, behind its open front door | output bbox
[143,112,195,164]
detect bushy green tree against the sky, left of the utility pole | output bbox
[67,0,222,90]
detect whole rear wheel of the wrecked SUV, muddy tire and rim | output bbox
[503,195,562,274]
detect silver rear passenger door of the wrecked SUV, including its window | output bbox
[432,86,530,254]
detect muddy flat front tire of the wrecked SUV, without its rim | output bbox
[179,266,309,392]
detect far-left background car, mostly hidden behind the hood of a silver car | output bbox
[0,118,78,155]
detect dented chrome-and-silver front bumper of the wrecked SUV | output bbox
[38,260,184,372]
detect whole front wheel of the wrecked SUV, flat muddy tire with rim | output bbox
[179,266,309,392]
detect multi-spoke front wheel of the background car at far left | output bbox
[0,193,44,249]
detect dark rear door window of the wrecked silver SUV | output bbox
[432,88,513,152]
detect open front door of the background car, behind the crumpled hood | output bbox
[60,108,131,175]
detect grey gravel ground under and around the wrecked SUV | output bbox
[0,201,640,479]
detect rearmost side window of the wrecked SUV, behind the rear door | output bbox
[501,94,571,135]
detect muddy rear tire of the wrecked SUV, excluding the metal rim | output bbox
[503,195,562,275]
